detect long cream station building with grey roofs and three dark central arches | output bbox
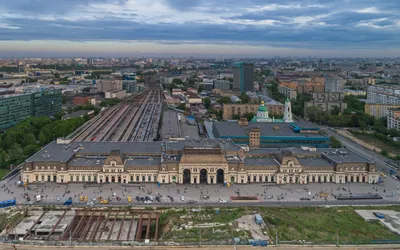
[22,139,379,184]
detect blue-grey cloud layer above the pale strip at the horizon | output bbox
[0,0,400,55]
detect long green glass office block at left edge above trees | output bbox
[0,89,62,130]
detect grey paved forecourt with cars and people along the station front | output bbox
[0,172,399,205]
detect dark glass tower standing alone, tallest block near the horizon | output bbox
[233,62,254,92]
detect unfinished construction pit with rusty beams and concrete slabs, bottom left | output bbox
[2,208,159,242]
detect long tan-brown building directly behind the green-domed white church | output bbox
[223,102,284,121]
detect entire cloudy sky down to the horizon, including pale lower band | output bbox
[0,0,400,57]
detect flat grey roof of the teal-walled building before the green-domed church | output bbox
[213,121,325,138]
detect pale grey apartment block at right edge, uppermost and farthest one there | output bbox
[367,85,400,105]
